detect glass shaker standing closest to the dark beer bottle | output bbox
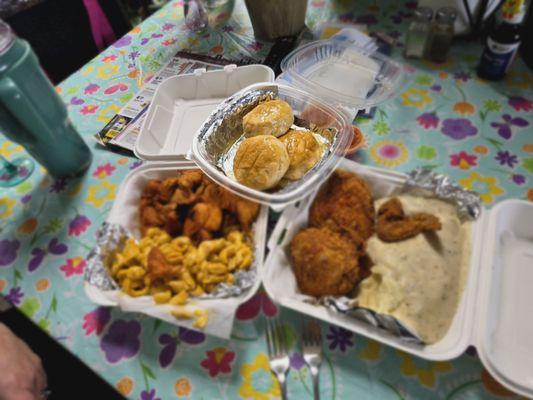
[426,7,457,62]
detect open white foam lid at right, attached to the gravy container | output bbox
[471,200,533,398]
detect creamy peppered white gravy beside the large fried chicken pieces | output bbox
[357,195,471,344]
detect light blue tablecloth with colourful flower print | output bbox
[0,0,533,400]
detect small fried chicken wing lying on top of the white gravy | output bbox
[376,197,442,242]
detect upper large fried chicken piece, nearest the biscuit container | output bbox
[309,170,374,241]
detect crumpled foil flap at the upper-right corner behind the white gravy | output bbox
[401,168,481,220]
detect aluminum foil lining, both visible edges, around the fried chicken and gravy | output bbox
[307,168,481,345]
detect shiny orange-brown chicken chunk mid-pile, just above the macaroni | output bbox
[183,203,222,240]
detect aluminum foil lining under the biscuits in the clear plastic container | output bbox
[193,85,340,194]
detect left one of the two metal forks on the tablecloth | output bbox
[266,318,290,400]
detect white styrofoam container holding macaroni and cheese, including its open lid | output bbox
[85,65,274,337]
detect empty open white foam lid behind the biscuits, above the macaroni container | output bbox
[134,65,274,161]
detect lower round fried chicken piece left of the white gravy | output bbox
[290,228,360,297]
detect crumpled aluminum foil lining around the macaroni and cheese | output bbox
[85,222,258,299]
